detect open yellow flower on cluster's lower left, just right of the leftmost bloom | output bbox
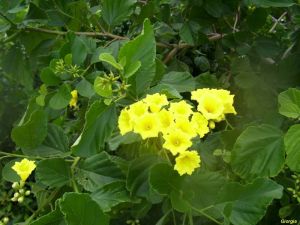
[134,113,159,139]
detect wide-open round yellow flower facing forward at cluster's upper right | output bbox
[197,92,224,120]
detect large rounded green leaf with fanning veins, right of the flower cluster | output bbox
[231,125,285,179]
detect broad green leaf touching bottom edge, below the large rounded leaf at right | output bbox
[219,178,283,225]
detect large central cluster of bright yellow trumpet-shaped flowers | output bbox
[118,89,236,175]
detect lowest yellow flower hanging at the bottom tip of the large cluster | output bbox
[174,151,201,176]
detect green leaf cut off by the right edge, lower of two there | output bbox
[284,124,300,172]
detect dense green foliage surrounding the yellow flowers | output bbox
[0,0,300,225]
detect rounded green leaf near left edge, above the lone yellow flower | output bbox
[11,110,47,148]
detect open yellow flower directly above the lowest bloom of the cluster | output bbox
[163,129,192,155]
